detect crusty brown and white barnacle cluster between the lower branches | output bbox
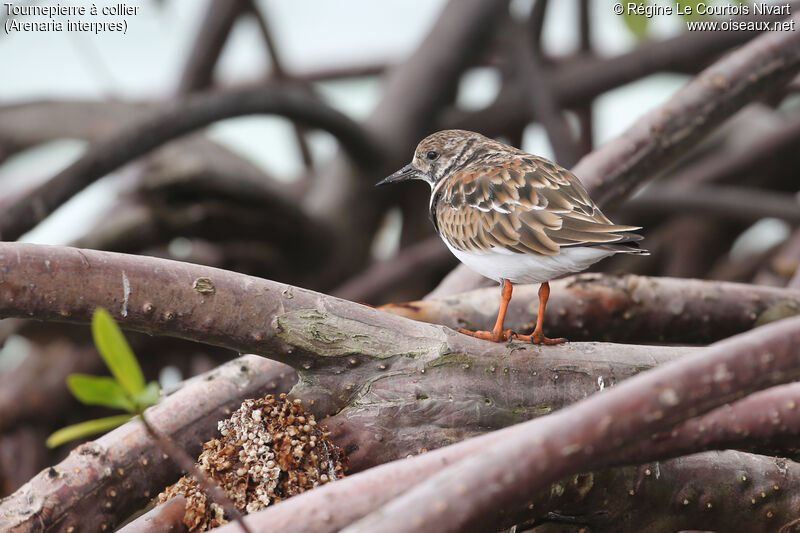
[157,394,344,531]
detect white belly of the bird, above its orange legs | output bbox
[442,239,614,283]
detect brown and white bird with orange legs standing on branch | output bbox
[377,130,649,345]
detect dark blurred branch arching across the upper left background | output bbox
[0,88,382,240]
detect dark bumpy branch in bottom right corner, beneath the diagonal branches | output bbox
[531,451,800,533]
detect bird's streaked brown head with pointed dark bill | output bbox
[377,130,492,188]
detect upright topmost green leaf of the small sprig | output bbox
[92,308,144,397]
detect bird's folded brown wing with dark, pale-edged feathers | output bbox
[433,156,639,255]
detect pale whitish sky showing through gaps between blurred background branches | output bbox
[0,0,686,244]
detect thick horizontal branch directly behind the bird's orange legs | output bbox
[381,274,800,343]
